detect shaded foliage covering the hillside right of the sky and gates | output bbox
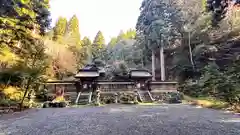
[133,0,240,107]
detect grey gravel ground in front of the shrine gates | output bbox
[0,105,240,135]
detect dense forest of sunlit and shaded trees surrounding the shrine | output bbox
[0,0,240,110]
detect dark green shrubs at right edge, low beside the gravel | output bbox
[180,62,240,104]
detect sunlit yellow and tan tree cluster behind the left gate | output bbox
[49,15,88,79]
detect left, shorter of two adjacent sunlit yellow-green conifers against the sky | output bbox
[53,17,67,41]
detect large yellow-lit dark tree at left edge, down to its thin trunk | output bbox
[0,0,49,107]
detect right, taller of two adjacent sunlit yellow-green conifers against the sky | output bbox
[66,15,81,46]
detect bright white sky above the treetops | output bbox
[50,0,142,42]
